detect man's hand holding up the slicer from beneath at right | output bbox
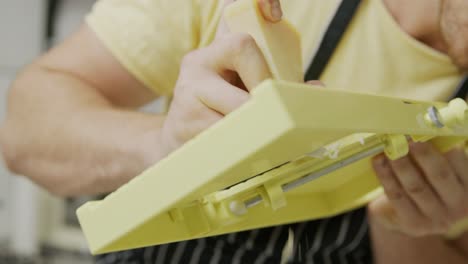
[369,143,468,237]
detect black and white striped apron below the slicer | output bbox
[96,208,372,264]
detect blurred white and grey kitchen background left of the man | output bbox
[0,0,149,264]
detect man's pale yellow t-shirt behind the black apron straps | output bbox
[87,0,461,100]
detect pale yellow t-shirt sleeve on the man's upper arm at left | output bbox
[86,0,200,95]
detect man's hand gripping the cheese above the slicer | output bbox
[161,0,281,153]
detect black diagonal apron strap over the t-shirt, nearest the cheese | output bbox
[304,0,361,81]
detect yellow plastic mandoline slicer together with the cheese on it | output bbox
[77,0,468,254]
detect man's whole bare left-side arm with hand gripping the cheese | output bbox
[0,0,286,196]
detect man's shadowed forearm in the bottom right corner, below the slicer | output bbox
[369,209,468,264]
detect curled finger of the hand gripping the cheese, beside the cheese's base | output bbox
[202,33,271,91]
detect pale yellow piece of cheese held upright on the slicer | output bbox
[224,0,304,82]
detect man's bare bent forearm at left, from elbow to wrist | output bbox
[0,65,165,196]
